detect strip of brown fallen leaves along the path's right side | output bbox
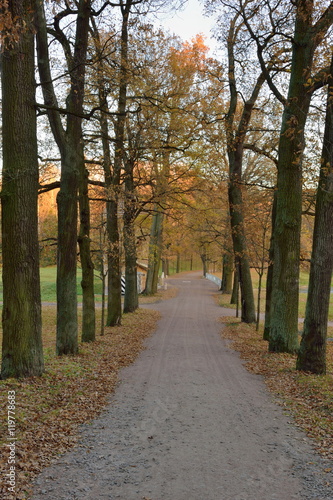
[221,317,333,460]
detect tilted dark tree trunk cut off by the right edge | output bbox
[296,59,333,374]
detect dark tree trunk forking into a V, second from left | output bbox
[36,0,91,355]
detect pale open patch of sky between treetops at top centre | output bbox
[152,0,216,54]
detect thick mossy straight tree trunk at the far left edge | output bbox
[1,0,44,378]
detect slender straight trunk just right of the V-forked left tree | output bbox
[78,166,96,342]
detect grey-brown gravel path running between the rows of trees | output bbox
[32,273,333,500]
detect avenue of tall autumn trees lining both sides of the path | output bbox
[0,0,333,378]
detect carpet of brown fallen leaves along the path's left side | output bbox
[0,304,161,500]
